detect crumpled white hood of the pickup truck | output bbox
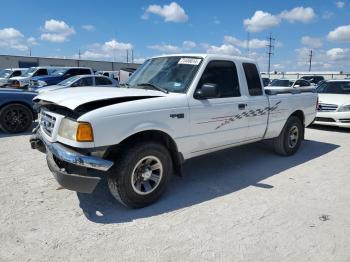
[33,87,167,110]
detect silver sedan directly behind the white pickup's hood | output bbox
[34,75,118,93]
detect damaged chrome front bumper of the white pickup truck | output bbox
[30,129,113,193]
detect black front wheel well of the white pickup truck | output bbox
[109,130,184,176]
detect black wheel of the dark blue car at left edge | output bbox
[0,104,33,133]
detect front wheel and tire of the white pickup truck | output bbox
[108,142,173,208]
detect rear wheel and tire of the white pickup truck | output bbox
[273,116,305,156]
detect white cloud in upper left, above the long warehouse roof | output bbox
[40,19,75,43]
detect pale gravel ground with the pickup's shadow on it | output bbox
[0,128,350,262]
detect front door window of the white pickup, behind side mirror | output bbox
[198,61,241,98]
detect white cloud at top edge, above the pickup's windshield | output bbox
[142,2,188,23]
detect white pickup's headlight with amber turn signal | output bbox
[58,118,94,142]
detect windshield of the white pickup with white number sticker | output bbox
[126,56,202,93]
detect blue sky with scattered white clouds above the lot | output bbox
[0,0,350,71]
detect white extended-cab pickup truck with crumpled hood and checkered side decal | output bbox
[30,54,317,208]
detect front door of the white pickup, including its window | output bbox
[189,61,248,154]
